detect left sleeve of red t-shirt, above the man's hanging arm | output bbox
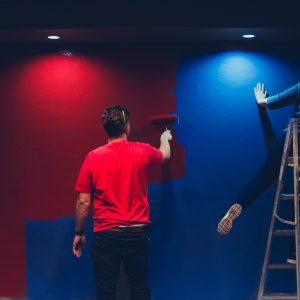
[75,153,93,193]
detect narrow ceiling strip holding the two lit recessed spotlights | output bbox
[0,27,300,45]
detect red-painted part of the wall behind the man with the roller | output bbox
[0,47,185,296]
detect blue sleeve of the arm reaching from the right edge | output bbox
[267,82,300,109]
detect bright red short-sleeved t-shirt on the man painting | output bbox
[75,141,163,231]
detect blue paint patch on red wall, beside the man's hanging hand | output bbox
[26,218,95,300]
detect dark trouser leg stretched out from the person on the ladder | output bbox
[233,132,286,209]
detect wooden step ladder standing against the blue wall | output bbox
[257,118,300,300]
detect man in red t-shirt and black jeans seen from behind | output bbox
[73,105,172,300]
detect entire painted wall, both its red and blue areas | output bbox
[0,45,300,300]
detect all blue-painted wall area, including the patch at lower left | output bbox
[27,46,300,300]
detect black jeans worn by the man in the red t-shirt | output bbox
[92,226,151,300]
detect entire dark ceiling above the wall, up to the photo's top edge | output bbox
[0,0,300,44]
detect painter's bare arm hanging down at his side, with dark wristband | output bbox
[73,193,92,258]
